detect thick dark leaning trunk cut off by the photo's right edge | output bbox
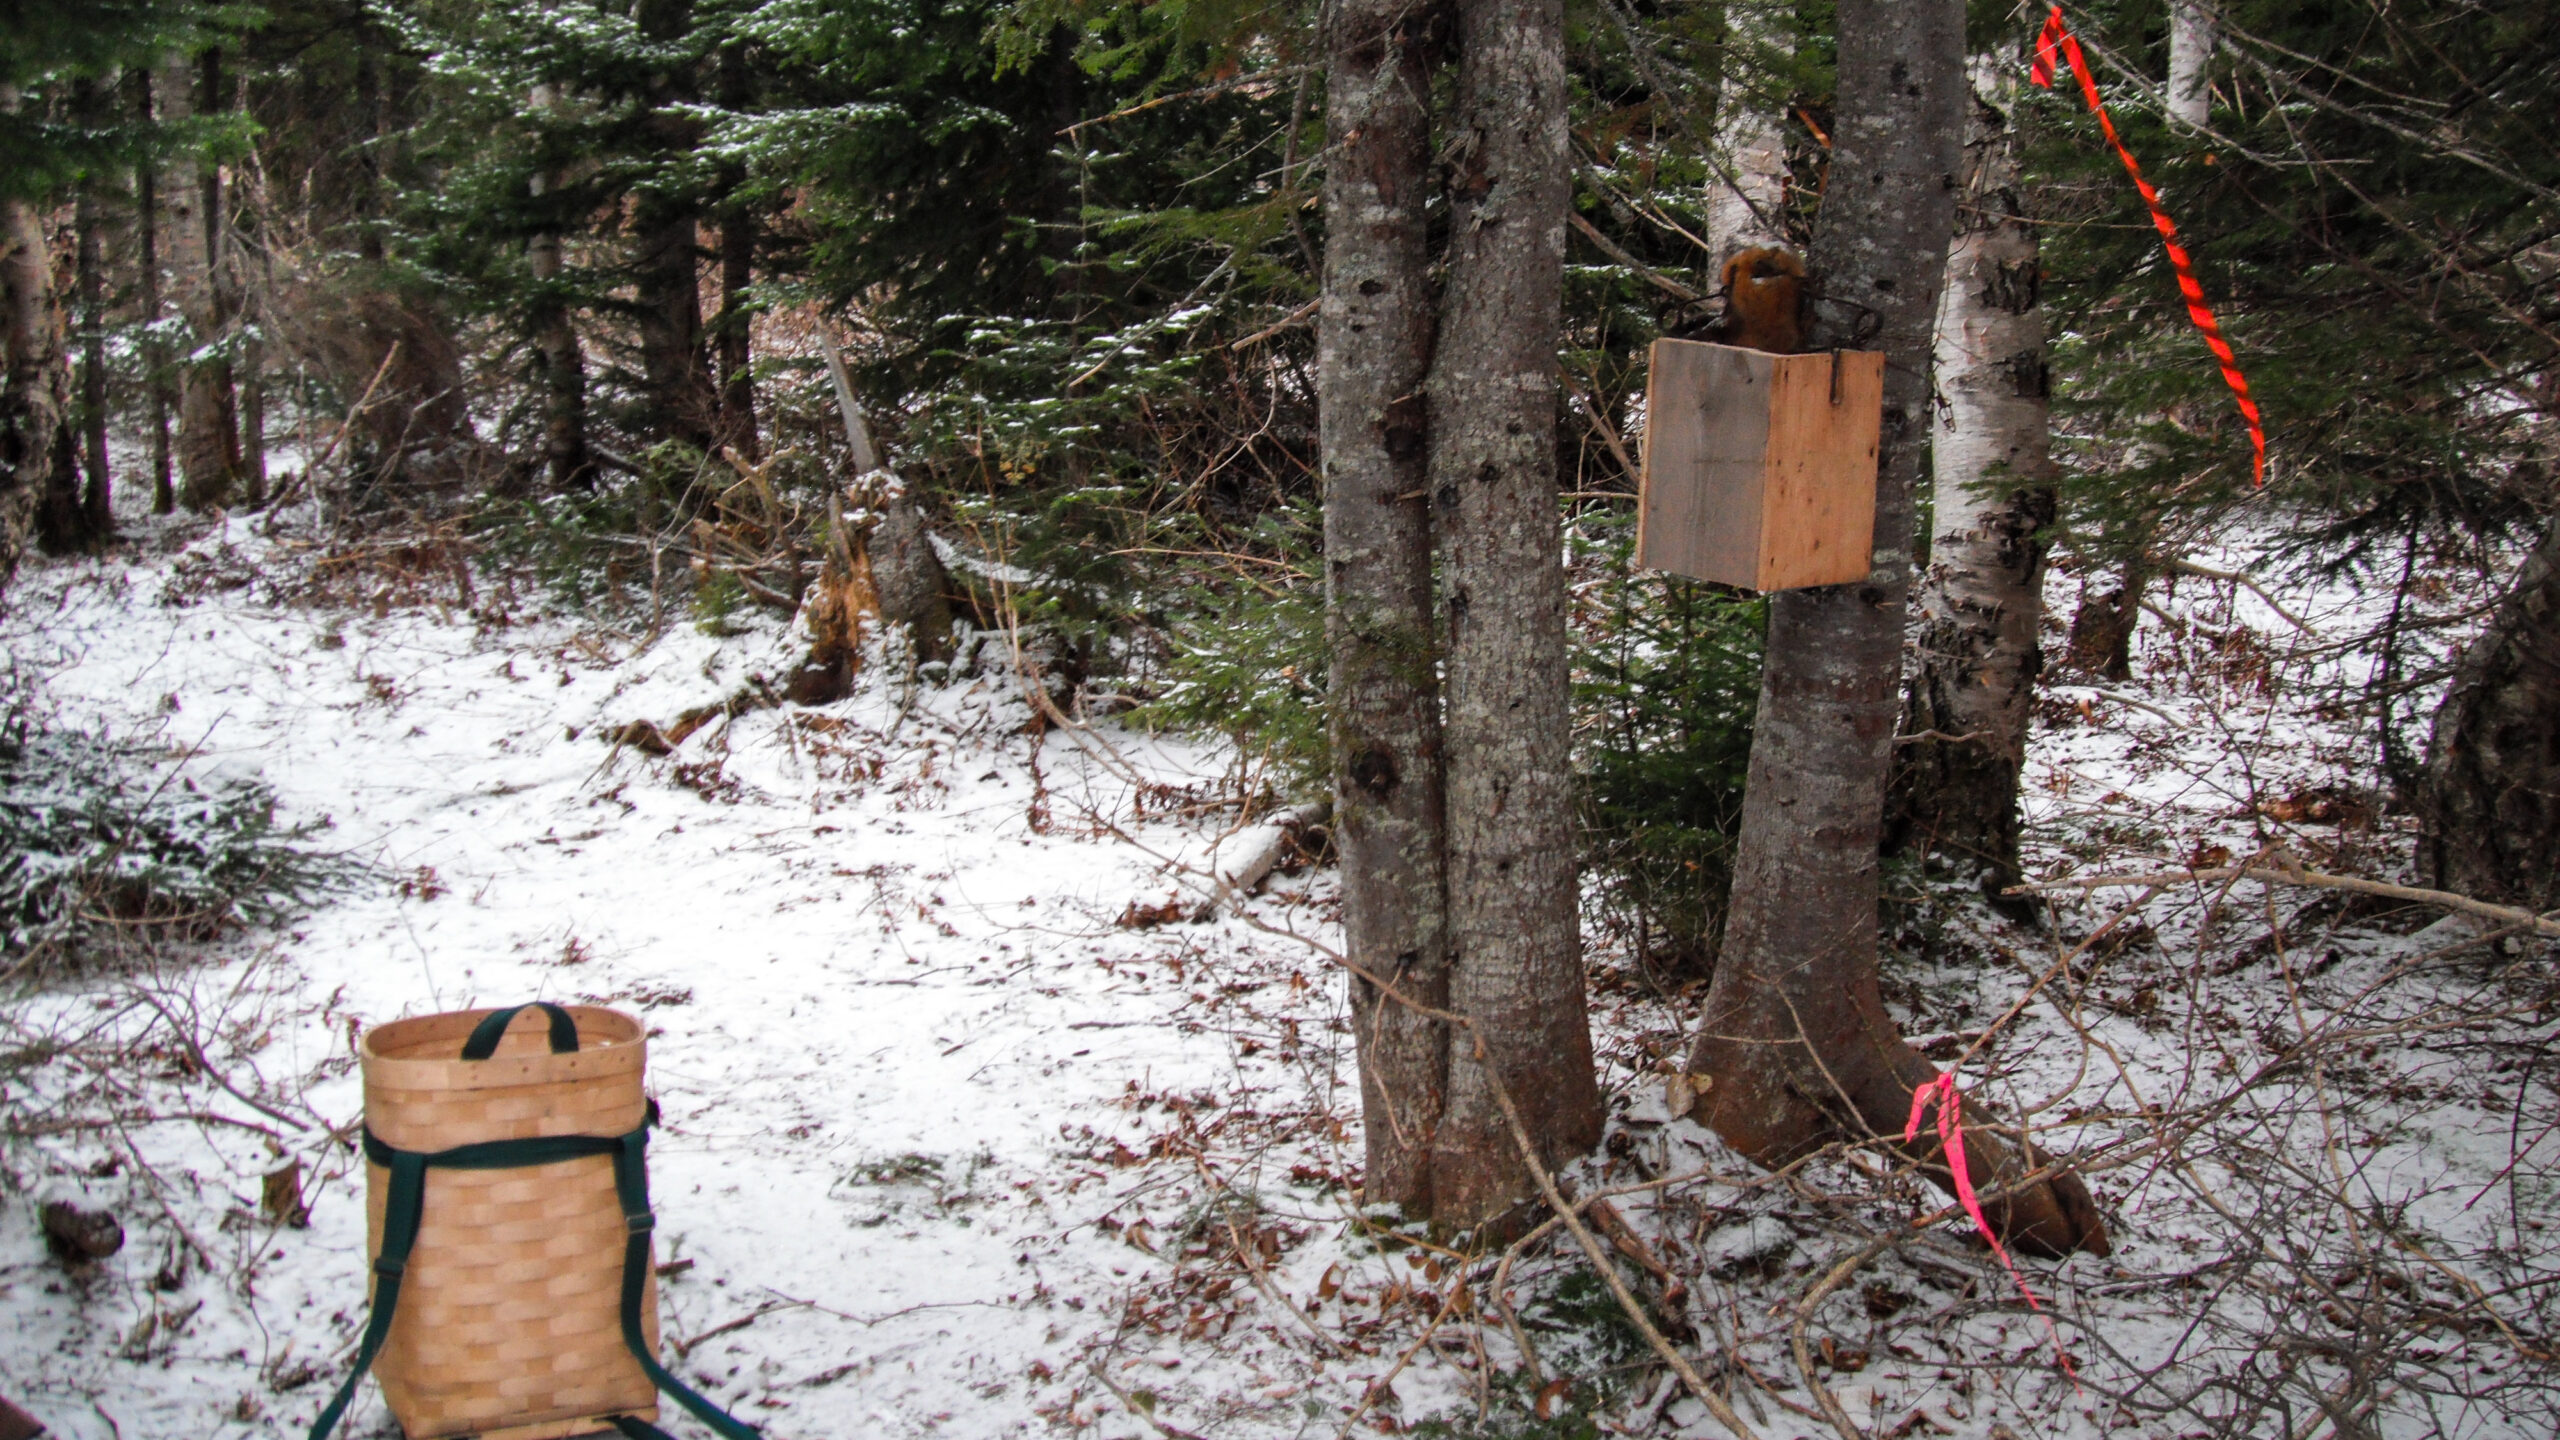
[2422,520,2560,910]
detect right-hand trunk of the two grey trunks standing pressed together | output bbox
[1423,0,1603,1225]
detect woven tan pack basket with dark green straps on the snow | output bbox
[312,1004,755,1440]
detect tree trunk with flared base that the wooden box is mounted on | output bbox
[1690,0,2107,1253]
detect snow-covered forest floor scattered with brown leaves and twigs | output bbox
[0,497,2555,1440]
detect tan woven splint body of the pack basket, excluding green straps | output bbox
[364,1007,658,1440]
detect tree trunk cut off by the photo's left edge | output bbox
[0,82,61,589]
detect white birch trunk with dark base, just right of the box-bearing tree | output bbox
[1884,73,2053,894]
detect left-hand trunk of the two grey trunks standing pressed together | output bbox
[1316,0,1449,1215]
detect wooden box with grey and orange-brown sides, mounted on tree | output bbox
[1636,341,1884,589]
